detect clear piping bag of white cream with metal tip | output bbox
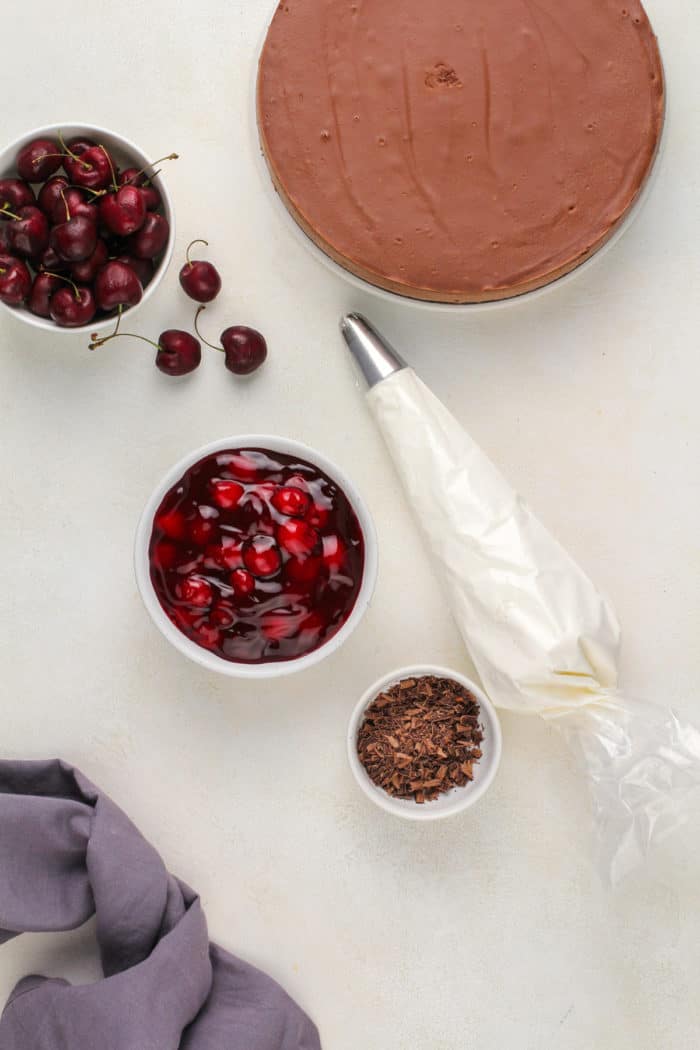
[341,314,700,884]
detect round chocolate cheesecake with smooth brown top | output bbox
[257,0,664,302]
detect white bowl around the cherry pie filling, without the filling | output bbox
[134,434,377,678]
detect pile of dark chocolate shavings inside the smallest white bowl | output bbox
[357,675,484,804]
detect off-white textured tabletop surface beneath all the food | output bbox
[0,0,700,1050]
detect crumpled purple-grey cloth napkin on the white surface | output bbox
[0,761,320,1050]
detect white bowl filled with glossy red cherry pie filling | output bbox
[134,435,377,678]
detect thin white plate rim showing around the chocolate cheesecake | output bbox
[248,4,670,317]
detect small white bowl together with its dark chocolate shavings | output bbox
[347,665,502,820]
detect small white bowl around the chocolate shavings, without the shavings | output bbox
[347,664,503,821]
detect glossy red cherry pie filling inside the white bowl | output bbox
[149,448,364,664]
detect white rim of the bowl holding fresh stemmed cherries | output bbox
[0,121,175,336]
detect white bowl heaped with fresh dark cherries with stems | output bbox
[0,123,175,333]
